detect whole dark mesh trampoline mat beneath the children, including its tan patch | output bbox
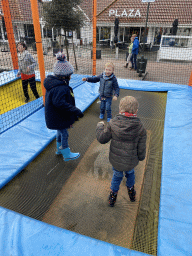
[0,89,167,255]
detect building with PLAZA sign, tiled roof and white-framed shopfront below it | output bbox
[93,0,192,45]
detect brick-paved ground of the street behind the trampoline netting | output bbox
[0,44,192,85]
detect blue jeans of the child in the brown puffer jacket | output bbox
[110,167,135,193]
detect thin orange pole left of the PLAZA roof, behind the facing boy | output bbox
[92,0,97,76]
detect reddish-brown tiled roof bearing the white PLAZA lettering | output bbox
[97,0,192,25]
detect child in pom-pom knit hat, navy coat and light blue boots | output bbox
[44,53,83,161]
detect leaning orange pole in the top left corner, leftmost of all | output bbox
[1,0,18,70]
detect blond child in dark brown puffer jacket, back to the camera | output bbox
[96,96,147,206]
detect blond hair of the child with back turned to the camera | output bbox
[119,96,139,114]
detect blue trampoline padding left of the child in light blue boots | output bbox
[0,108,56,188]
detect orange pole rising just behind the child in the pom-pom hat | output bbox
[31,0,46,104]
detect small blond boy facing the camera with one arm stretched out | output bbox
[82,62,119,122]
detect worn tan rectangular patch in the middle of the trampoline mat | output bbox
[43,136,150,248]
